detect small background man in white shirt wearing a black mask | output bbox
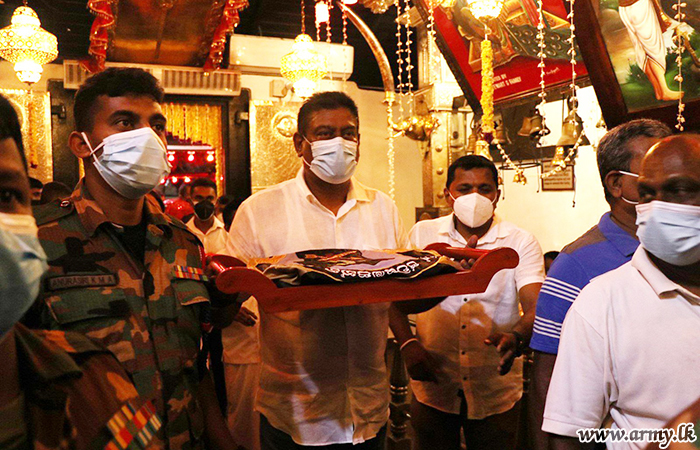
[187,178,228,254]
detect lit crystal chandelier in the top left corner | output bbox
[0,0,58,85]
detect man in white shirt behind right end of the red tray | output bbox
[391,155,544,450]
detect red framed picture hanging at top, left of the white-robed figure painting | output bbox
[415,0,592,111]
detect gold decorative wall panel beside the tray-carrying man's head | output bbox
[250,100,302,192]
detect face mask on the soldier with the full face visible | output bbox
[82,127,172,199]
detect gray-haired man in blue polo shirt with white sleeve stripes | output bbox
[528,119,671,450]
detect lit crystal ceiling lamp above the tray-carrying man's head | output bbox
[280,34,328,98]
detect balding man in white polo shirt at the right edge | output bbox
[542,135,700,450]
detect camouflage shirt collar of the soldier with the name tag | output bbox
[71,179,170,237]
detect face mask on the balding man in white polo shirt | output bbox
[636,200,700,266]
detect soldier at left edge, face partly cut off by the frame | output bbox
[0,92,163,450]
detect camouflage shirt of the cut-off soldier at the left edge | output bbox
[0,324,163,450]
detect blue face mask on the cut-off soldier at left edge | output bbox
[0,213,48,336]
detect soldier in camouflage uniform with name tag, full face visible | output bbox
[30,69,235,450]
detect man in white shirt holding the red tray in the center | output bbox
[227,92,408,449]
